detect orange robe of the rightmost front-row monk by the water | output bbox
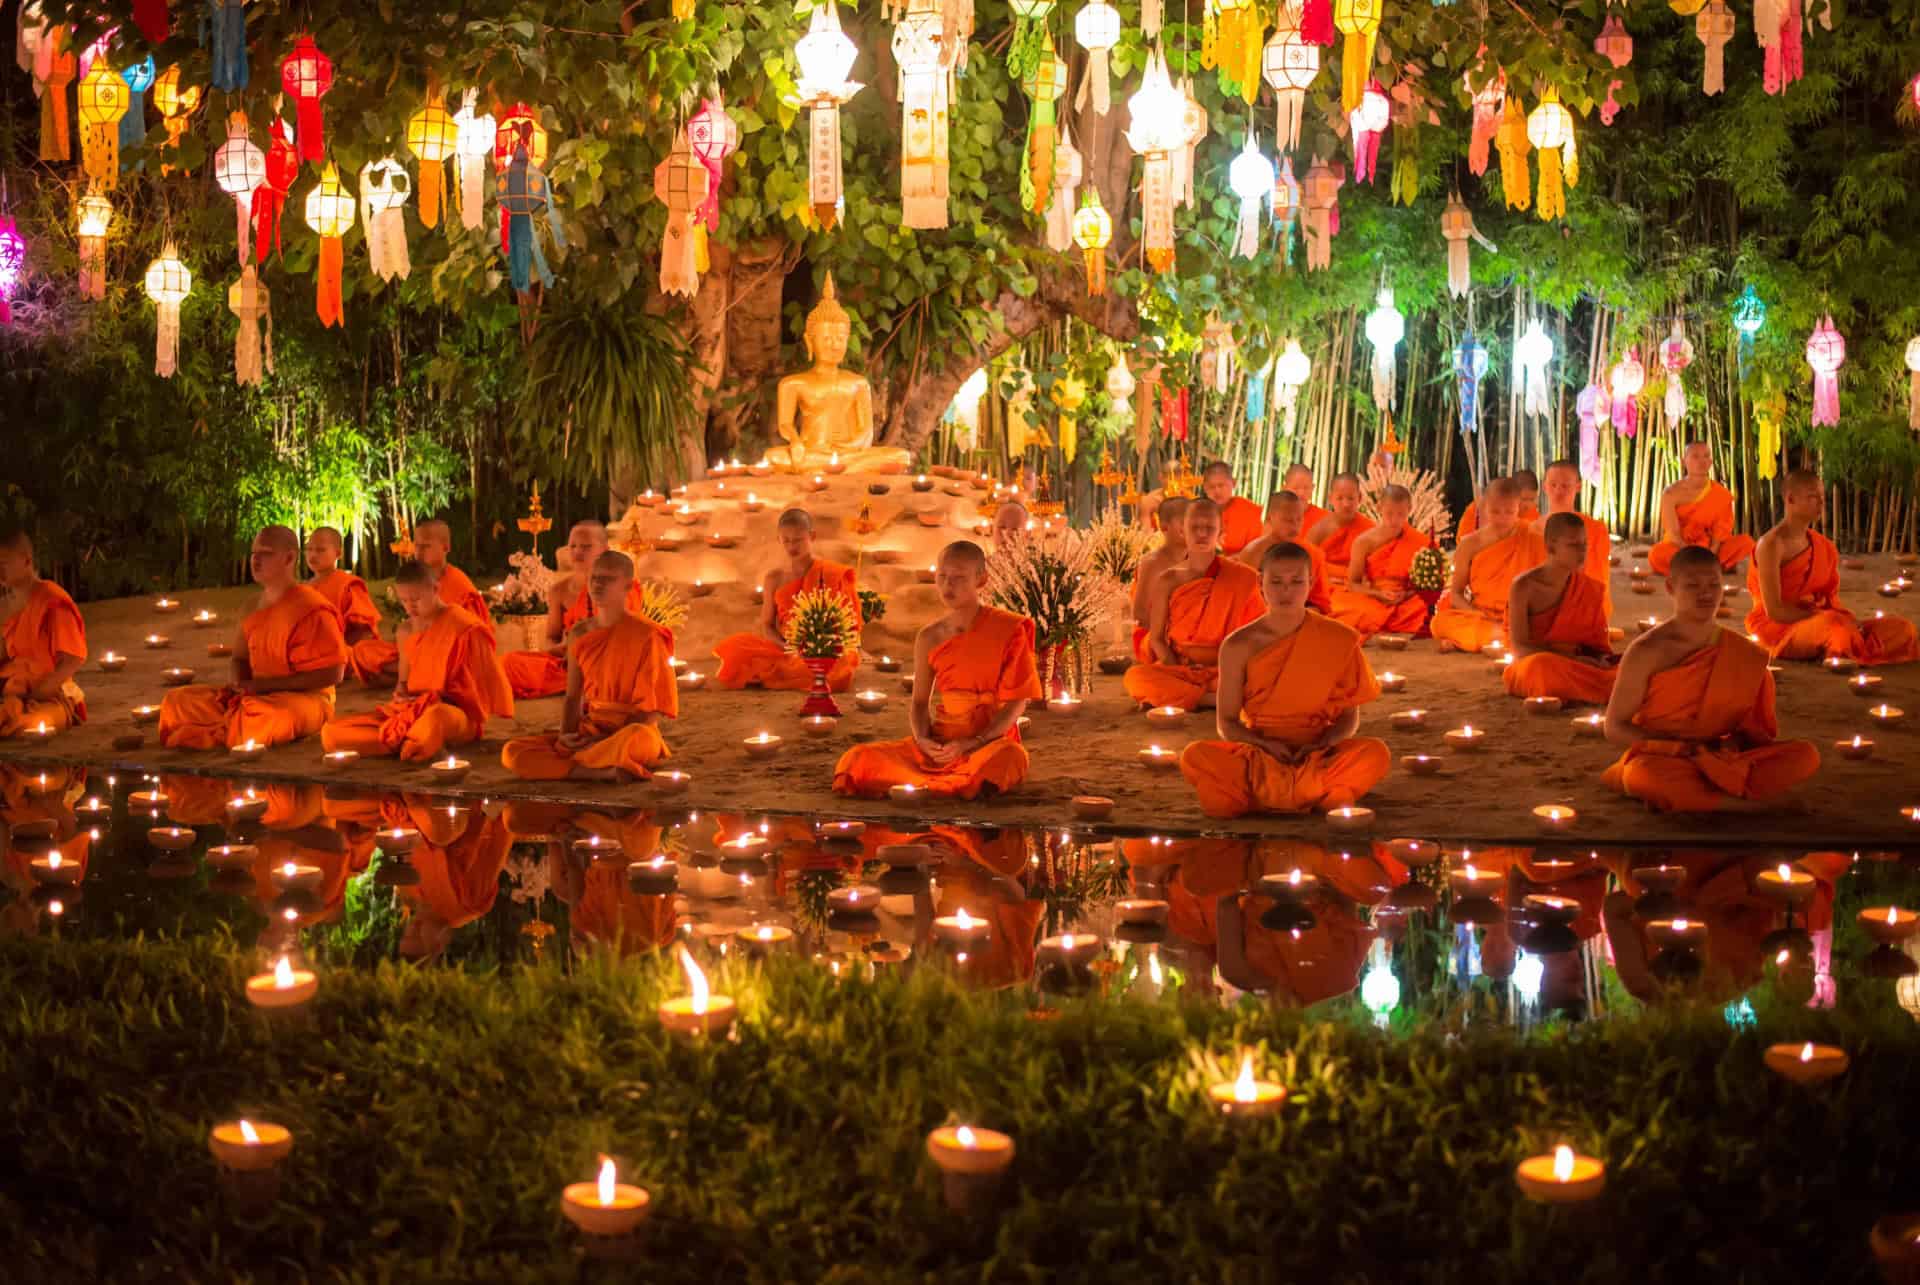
[1605,630,1820,812]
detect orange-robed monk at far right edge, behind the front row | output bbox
[1747,469,1920,665]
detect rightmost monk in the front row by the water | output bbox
[1605,546,1820,812]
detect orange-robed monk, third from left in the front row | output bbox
[321,561,513,763]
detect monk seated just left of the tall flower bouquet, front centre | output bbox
[833,540,1044,799]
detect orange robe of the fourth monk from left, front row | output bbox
[499,617,680,782]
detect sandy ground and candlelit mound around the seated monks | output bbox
[11,466,1920,849]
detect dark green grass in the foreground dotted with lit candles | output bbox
[0,937,1920,1285]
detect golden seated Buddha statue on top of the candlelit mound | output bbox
[768,275,912,473]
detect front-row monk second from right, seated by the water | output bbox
[1181,544,1394,816]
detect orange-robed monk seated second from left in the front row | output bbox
[159,526,348,749]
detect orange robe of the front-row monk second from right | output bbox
[1181,615,1394,816]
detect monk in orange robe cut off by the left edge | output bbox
[0,532,86,738]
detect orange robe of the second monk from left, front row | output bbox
[159,584,348,749]
